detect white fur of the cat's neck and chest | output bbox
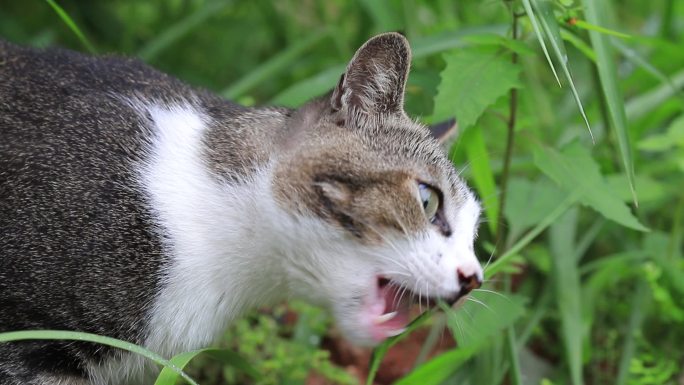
[140,101,288,354]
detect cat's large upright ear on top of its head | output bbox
[330,32,411,115]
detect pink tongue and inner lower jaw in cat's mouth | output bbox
[370,282,411,342]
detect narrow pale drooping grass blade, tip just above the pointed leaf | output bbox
[531,0,594,142]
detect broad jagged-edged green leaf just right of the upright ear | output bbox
[432,47,521,129]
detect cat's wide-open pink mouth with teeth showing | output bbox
[368,276,469,342]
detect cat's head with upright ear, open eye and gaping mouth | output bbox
[273,33,482,345]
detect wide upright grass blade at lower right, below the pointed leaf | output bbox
[550,208,583,385]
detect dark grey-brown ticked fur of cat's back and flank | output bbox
[0,41,186,340]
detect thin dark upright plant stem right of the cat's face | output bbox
[494,7,518,251]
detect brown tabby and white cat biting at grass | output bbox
[0,34,482,385]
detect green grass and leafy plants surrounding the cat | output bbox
[0,0,684,385]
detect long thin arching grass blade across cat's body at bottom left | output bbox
[0,330,198,385]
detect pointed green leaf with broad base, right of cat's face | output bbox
[534,142,648,231]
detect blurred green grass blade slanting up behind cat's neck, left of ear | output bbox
[221,29,330,99]
